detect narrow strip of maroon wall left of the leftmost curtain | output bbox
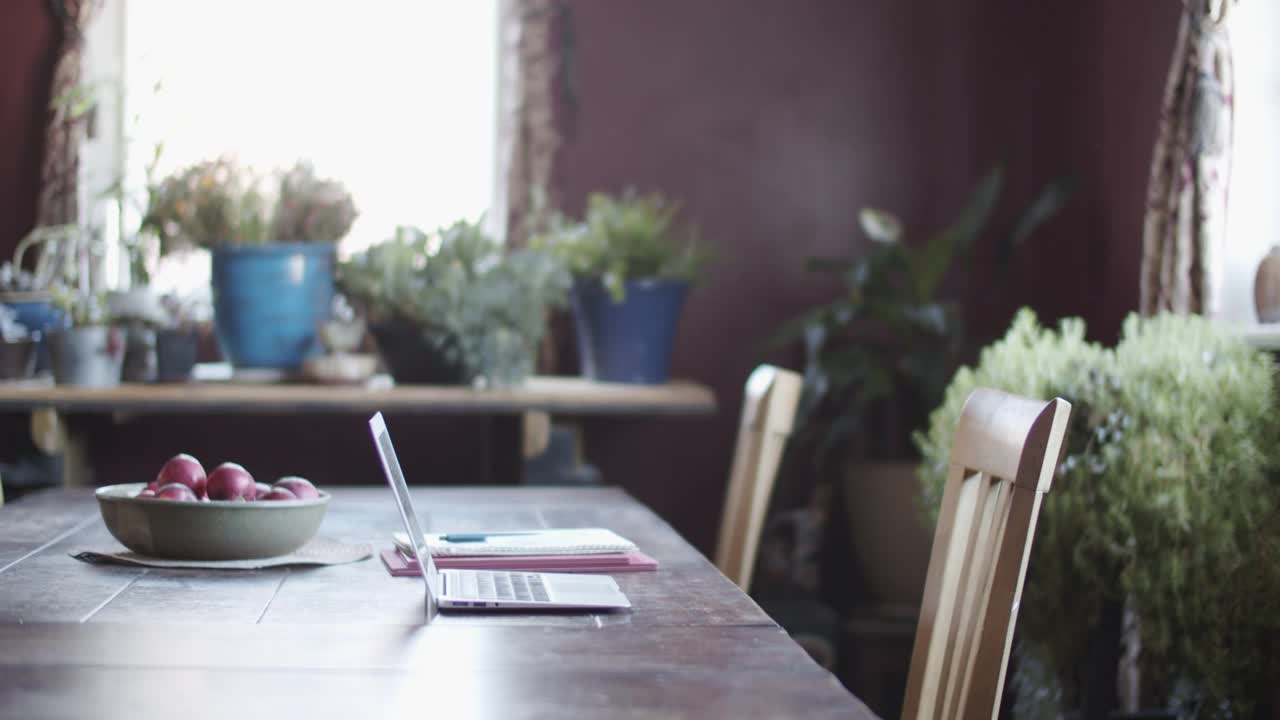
[0,0,56,260]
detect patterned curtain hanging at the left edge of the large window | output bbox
[36,0,99,225]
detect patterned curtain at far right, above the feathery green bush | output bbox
[1142,0,1234,315]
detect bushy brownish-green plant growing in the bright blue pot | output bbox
[142,158,356,252]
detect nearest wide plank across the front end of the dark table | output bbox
[0,623,872,719]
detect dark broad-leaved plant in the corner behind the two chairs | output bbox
[773,168,1071,465]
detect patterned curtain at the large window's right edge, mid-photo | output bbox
[499,0,567,247]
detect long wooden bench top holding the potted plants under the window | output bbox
[0,377,716,415]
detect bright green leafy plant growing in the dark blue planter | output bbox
[531,190,710,302]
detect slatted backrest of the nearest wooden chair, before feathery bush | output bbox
[902,388,1071,720]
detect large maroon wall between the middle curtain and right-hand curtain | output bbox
[556,0,1180,548]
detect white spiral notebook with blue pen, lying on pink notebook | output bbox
[393,528,639,557]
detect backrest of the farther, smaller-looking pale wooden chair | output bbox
[716,365,804,591]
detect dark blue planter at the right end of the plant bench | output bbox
[570,279,689,384]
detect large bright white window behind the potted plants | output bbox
[86,0,498,292]
